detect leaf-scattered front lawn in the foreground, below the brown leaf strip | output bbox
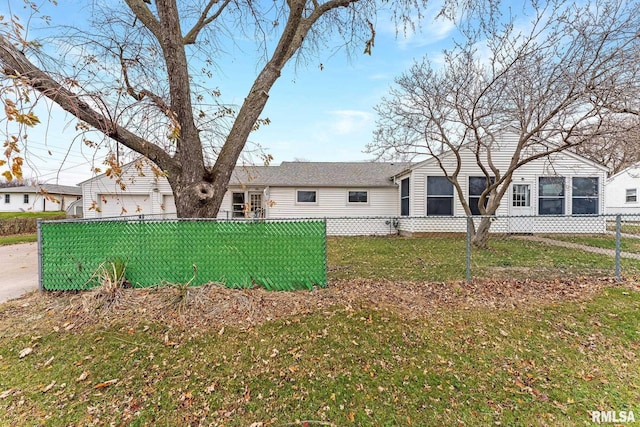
[0,288,640,426]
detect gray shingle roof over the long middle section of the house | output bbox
[229,162,410,187]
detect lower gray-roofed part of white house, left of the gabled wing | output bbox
[80,162,407,227]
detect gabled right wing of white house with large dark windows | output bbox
[395,133,607,234]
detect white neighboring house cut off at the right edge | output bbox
[604,163,640,214]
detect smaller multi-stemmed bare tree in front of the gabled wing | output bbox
[368,0,640,247]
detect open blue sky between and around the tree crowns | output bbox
[0,0,453,185]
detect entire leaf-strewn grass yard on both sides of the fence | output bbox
[0,237,640,426]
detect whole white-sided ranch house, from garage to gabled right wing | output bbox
[81,134,607,234]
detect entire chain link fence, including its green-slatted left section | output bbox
[39,214,640,290]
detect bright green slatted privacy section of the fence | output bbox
[38,219,327,290]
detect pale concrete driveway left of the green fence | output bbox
[0,243,38,303]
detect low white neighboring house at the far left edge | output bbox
[0,184,82,212]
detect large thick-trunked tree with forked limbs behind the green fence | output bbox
[0,0,448,217]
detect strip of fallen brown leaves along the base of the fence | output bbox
[0,278,640,334]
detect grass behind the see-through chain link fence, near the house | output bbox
[327,237,640,281]
